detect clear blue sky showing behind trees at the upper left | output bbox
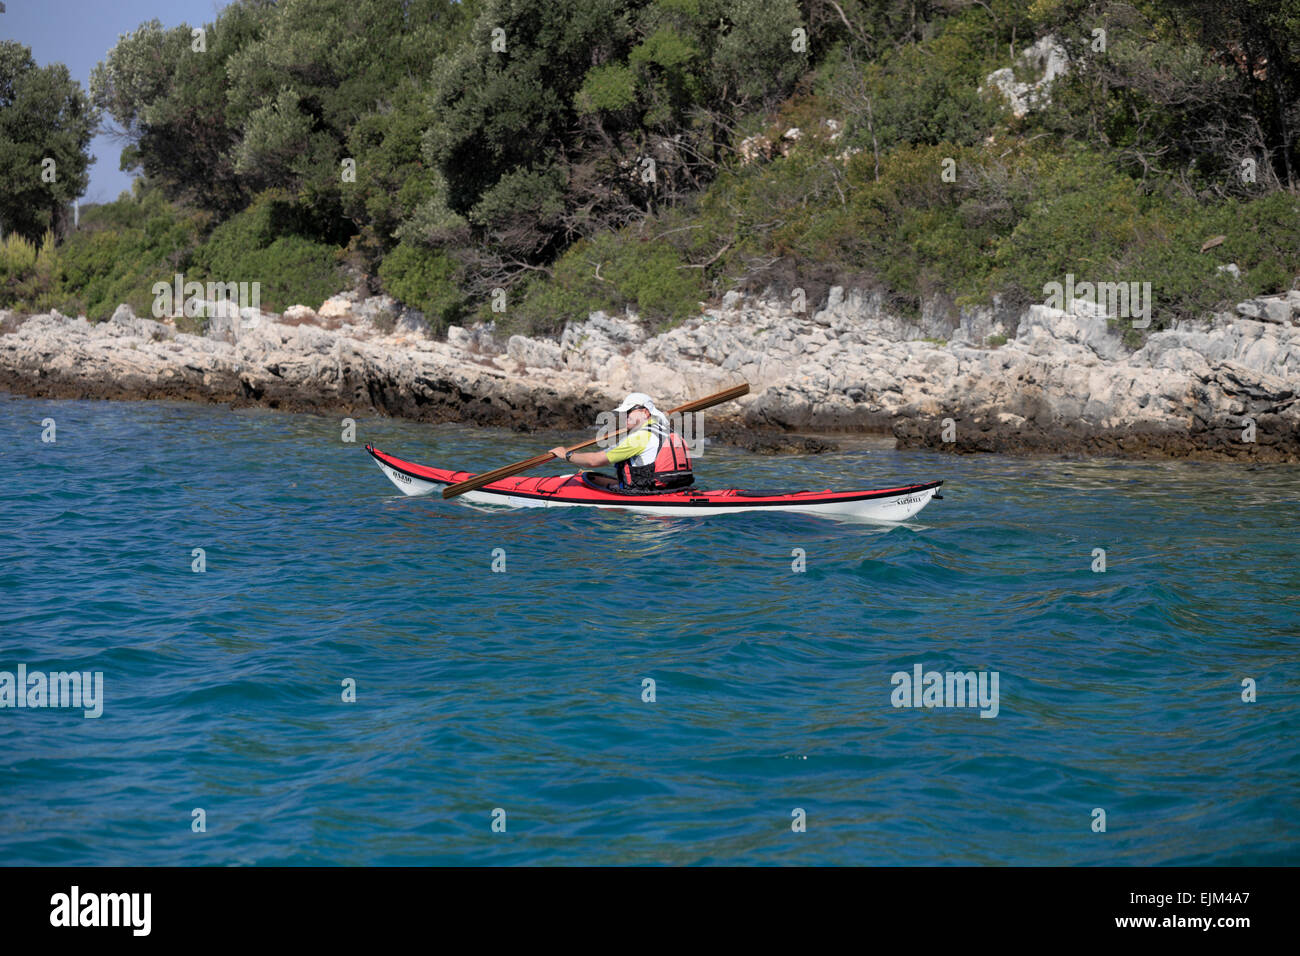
[0,0,226,203]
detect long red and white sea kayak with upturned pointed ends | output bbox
[365,445,944,522]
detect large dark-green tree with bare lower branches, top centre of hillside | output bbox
[417,0,810,291]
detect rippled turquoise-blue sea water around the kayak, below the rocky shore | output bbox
[0,395,1300,865]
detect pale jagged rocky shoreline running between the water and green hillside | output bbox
[0,289,1300,462]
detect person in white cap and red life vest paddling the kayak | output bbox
[551,392,696,494]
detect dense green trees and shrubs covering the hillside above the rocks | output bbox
[0,0,1300,340]
